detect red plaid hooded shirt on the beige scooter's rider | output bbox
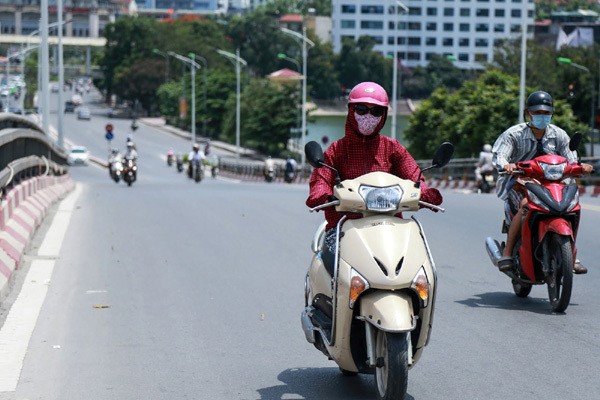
[306,110,442,229]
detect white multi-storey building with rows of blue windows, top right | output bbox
[331,0,535,69]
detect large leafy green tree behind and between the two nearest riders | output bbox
[404,70,586,158]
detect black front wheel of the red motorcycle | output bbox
[546,233,573,312]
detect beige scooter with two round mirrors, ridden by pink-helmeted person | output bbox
[301,142,454,400]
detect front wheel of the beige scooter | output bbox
[375,330,409,400]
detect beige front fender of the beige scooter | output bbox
[360,291,417,332]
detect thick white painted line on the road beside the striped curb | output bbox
[0,185,81,392]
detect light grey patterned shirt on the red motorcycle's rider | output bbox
[492,123,577,200]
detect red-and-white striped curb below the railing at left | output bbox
[0,174,75,300]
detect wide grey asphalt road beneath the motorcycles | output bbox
[0,90,600,400]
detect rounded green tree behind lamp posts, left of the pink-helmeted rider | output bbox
[223,79,298,155]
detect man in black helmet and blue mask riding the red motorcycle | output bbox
[492,90,593,274]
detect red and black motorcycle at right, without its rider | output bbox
[486,133,583,312]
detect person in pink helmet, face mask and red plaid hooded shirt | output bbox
[306,82,442,271]
